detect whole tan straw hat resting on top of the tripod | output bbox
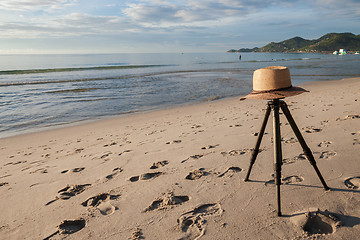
[241,66,307,100]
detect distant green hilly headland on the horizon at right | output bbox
[227,33,360,53]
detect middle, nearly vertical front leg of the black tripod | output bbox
[272,100,282,216]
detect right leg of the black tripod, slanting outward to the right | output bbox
[280,102,330,190]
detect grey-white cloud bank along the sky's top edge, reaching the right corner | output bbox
[123,0,360,26]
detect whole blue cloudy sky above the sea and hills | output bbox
[0,0,360,54]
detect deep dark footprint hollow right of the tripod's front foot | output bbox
[291,209,340,235]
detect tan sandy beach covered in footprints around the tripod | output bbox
[0,78,360,239]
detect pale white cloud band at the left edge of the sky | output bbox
[0,10,149,39]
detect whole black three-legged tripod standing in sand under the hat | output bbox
[245,99,330,216]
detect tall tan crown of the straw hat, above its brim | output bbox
[253,66,291,91]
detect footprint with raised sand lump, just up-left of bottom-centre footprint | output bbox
[144,192,190,212]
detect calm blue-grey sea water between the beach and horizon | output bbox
[0,53,360,138]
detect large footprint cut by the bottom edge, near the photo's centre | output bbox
[177,203,223,240]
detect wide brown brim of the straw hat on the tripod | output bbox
[241,86,308,100]
